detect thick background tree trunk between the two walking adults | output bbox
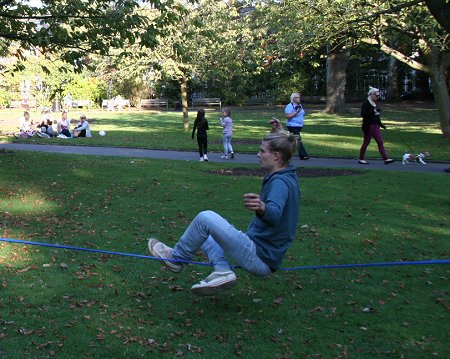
[324,50,350,113]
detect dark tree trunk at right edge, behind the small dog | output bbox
[424,46,450,137]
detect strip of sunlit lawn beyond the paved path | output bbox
[3,103,450,161]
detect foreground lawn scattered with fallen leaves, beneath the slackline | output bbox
[0,150,450,359]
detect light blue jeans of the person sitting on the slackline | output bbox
[172,211,271,276]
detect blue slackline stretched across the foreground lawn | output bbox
[0,238,450,271]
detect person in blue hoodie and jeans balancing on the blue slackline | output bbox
[148,131,300,295]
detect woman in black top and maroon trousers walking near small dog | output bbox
[358,87,394,165]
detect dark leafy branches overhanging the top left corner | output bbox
[0,0,176,70]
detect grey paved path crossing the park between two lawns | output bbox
[0,143,450,175]
